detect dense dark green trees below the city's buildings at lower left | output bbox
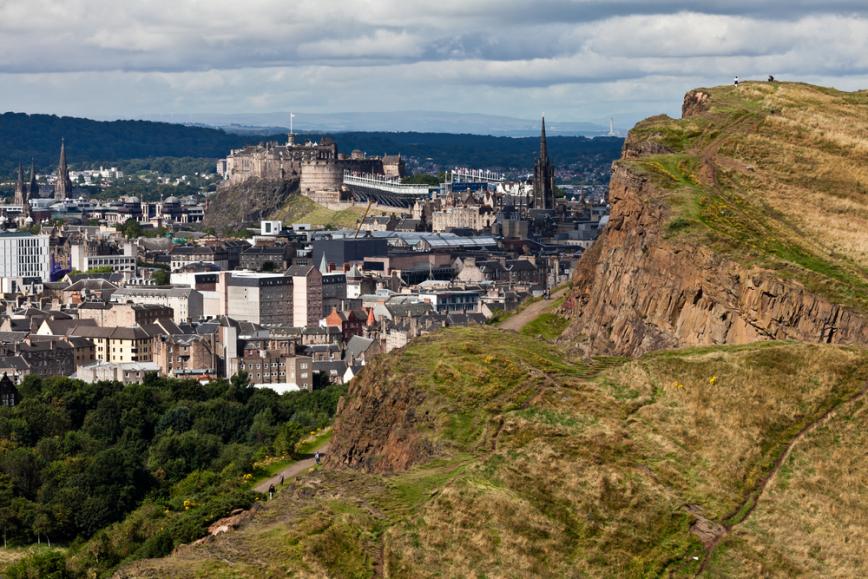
[0,374,344,577]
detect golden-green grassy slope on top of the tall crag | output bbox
[619,83,868,312]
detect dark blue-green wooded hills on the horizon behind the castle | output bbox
[0,113,623,179]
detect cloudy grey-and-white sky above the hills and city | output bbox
[0,0,868,126]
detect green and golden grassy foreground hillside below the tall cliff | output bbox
[127,328,868,577]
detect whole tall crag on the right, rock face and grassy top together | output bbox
[565,84,868,354]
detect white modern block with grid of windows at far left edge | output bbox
[0,232,51,293]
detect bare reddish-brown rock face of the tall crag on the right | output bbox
[564,84,868,355]
